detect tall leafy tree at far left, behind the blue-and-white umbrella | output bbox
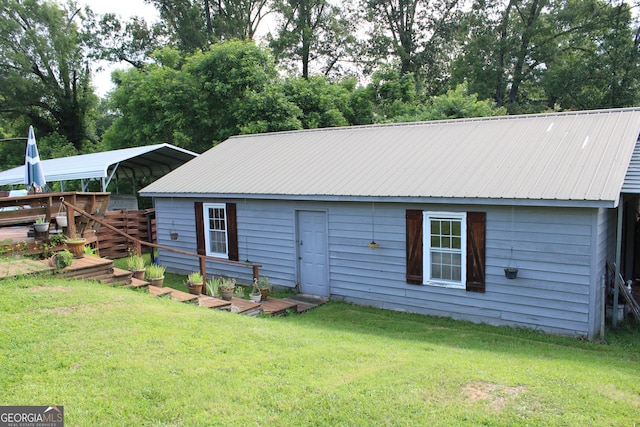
[0,0,97,151]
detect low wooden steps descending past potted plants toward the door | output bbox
[42,256,323,316]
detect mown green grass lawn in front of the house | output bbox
[0,277,640,426]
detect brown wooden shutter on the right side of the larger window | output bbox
[467,212,487,292]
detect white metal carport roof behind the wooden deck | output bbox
[0,144,198,190]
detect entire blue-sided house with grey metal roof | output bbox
[141,109,640,338]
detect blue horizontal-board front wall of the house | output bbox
[156,198,615,337]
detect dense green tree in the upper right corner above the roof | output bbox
[541,2,640,110]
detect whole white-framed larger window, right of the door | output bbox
[423,212,467,288]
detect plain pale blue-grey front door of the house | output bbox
[297,211,329,297]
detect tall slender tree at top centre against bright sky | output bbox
[269,0,355,79]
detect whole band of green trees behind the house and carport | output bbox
[0,0,640,162]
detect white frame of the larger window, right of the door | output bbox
[422,211,467,289]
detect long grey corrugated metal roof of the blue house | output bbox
[142,109,640,205]
